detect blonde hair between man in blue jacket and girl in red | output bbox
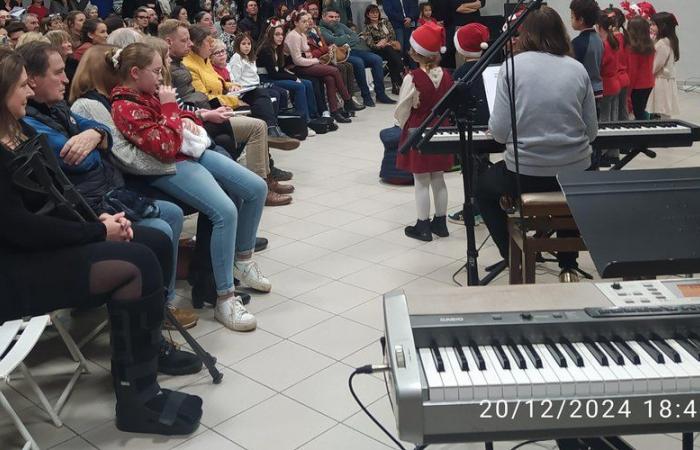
[68,45,119,103]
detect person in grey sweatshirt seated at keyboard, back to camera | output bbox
[476,7,598,281]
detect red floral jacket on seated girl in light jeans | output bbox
[111,86,202,162]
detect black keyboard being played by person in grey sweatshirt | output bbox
[410,120,700,153]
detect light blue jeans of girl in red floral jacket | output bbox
[151,150,267,295]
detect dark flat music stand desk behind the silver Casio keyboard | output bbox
[557,167,700,278]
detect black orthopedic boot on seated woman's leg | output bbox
[108,289,202,435]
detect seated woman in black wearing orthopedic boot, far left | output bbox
[0,49,202,435]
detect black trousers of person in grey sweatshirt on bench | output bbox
[476,161,578,269]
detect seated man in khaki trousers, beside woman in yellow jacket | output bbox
[158,19,292,206]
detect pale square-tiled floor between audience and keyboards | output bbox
[0,89,700,450]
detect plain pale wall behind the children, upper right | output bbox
[483,0,700,84]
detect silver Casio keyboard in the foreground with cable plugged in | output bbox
[384,279,700,444]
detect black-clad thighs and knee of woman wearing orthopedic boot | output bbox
[0,227,172,323]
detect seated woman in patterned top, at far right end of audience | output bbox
[363,5,403,95]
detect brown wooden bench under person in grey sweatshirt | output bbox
[501,192,586,284]
